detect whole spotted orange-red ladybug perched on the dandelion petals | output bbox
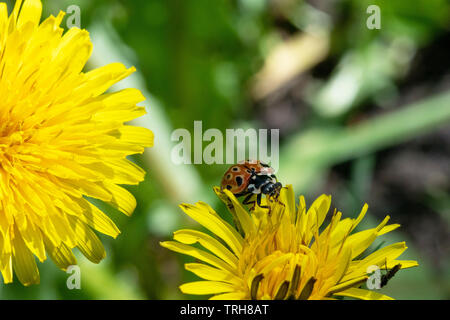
[220,160,282,207]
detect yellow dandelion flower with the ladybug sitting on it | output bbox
[161,186,418,300]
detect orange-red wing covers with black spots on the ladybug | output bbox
[220,160,274,196]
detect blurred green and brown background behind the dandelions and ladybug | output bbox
[0,0,450,299]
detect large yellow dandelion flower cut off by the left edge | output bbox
[0,0,153,285]
